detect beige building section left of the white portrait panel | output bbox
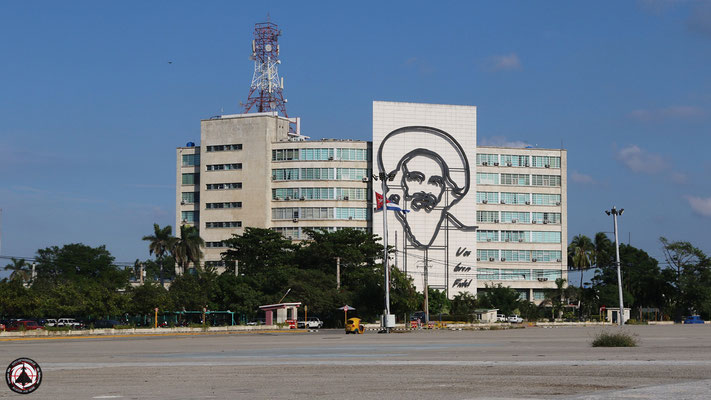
[175,113,370,273]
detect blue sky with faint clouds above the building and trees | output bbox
[0,0,711,276]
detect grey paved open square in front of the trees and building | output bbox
[0,325,711,399]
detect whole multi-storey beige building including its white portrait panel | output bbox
[176,101,567,302]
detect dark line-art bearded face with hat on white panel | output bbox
[378,127,476,249]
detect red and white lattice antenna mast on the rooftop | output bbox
[244,21,289,118]
